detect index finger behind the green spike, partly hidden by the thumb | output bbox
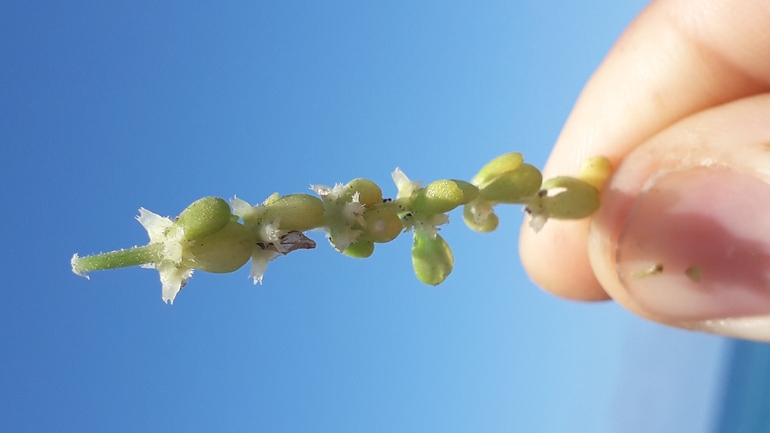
[520,0,770,300]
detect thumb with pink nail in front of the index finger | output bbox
[589,93,770,341]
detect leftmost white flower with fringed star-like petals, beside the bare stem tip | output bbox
[136,208,193,304]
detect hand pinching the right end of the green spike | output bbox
[520,0,770,341]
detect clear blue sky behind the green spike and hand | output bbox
[0,0,728,432]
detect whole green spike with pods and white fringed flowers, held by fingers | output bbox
[71,153,604,304]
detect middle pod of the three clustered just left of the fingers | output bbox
[479,164,543,203]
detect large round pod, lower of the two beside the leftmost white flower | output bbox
[187,222,256,274]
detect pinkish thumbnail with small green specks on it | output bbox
[616,167,770,321]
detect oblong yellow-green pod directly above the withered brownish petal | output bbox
[260,194,324,232]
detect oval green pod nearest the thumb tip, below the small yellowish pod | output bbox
[540,176,599,219]
